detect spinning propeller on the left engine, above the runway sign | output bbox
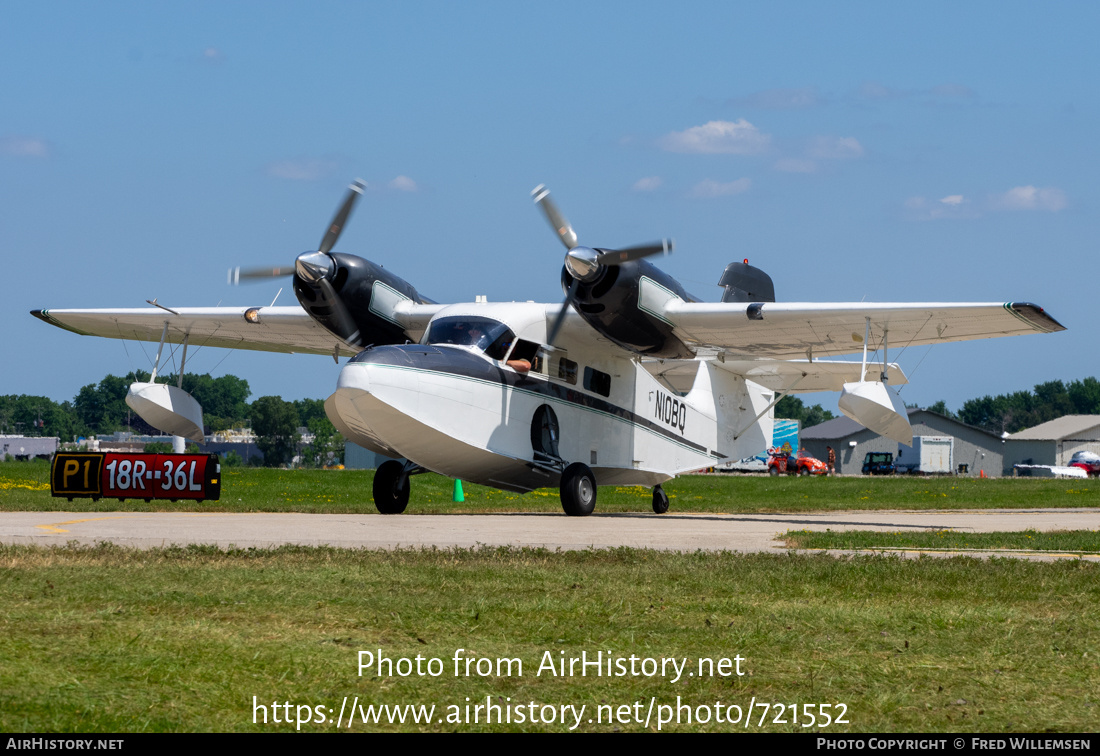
[229,179,366,347]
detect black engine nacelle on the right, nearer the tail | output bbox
[561,258,697,359]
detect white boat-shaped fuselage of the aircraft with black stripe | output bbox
[326,304,770,491]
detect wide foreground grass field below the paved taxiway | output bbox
[0,546,1100,733]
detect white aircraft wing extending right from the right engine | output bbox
[644,297,1065,360]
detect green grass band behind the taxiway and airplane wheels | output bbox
[0,462,1100,514]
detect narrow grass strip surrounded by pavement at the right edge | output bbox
[781,530,1100,554]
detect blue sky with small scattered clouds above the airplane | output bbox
[0,0,1100,409]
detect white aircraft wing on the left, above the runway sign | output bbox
[31,302,442,355]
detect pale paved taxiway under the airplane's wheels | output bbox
[0,508,1100,559]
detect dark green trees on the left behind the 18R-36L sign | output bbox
[0,370,343,467]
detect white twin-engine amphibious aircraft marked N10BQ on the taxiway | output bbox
[33,182,1064,515]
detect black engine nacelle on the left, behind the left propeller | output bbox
[294,253,431,347]
